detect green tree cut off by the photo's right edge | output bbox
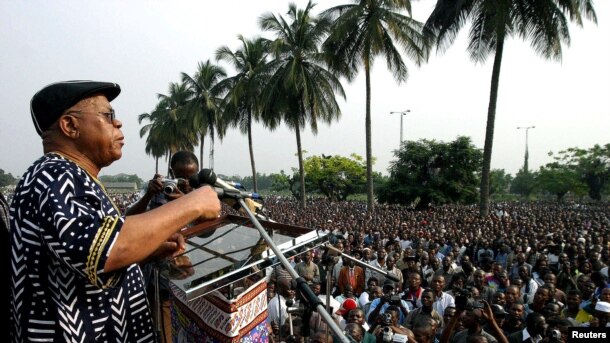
[555,143,610,201]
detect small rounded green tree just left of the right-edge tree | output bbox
[536,162,586,202]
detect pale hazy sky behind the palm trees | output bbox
[0,0,610,183]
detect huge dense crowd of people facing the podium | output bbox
[254,197,610,343]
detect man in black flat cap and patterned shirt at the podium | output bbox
[10,81,220,342]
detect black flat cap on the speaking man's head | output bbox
[30,80,121,135]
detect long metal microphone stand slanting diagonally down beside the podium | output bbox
[236,197,350,343]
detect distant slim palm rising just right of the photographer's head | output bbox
[181,60,227,168]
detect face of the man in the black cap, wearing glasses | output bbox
[67,94,125,168]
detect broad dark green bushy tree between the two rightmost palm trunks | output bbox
[379,137,482,208]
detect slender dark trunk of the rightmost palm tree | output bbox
[479,34,504,217]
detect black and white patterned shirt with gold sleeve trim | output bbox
[10,153,154,342]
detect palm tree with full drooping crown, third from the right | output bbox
[260,1,345,208]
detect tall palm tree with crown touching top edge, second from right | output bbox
[323,0,429,212]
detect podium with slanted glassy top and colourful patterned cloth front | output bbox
[162,215,328,342]
